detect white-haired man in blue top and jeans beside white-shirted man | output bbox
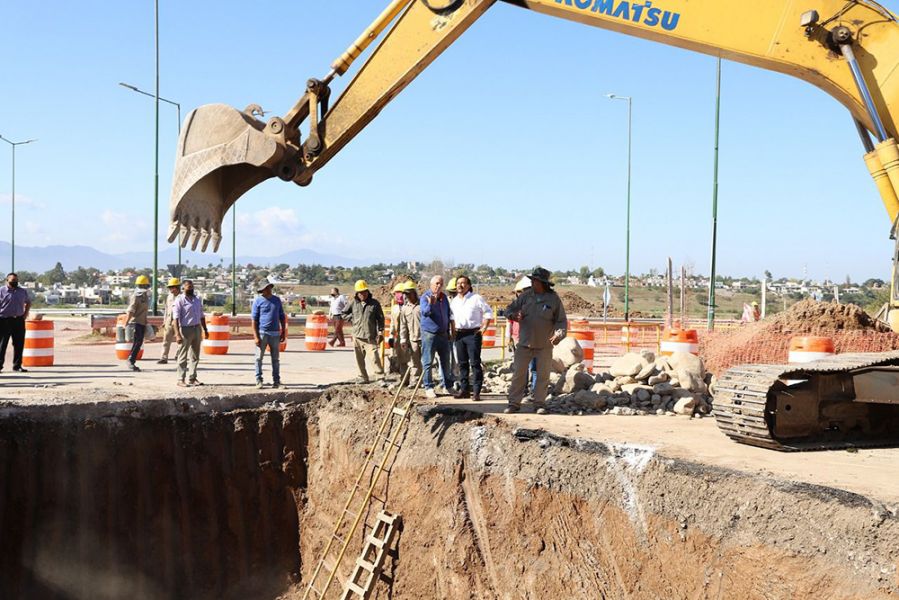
[419,275,453,398]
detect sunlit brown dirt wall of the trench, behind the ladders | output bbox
[301,396,899,600]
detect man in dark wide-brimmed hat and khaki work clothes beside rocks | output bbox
[504,268,568,414]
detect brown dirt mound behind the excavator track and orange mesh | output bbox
[699,300,899,375]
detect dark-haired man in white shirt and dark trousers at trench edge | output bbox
[450,275,493,402]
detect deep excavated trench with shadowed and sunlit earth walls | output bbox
[0,386,899,600]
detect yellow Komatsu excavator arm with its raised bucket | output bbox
[168,0,899,326]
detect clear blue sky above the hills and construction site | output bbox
[0,0,899,281]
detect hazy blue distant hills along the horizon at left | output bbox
[0,242,367,273]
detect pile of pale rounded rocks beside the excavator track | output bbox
[484,340,714,417]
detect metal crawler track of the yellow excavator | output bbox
[713,351,899,452]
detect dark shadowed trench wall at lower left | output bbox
[0,402,307,600]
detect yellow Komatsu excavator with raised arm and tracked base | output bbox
[168,0,899,450]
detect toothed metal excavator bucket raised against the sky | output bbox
[168,104,287,252]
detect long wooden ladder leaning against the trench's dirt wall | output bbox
[303,367,424,600]
